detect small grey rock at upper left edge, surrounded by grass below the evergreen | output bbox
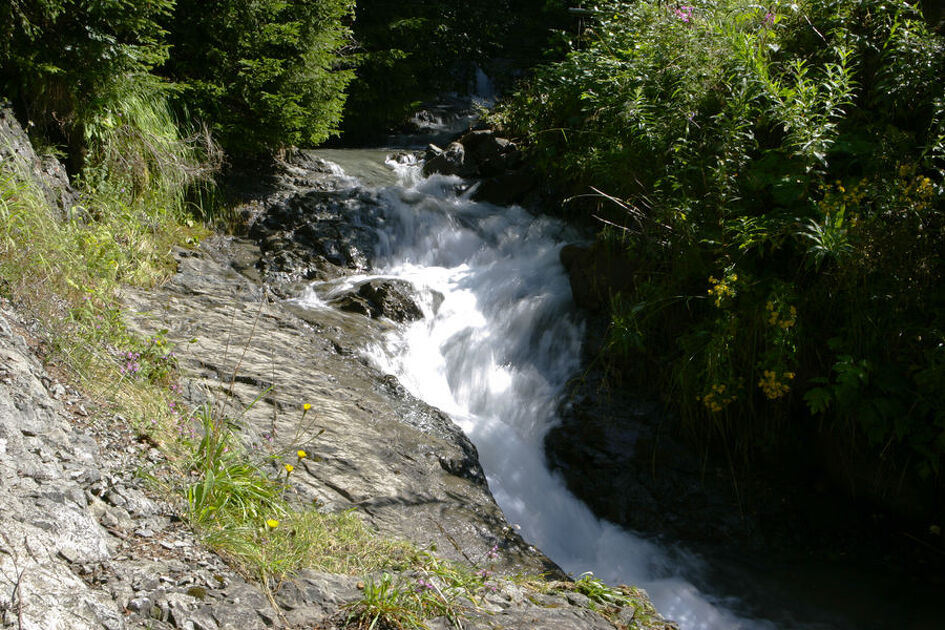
[0,101,79,217]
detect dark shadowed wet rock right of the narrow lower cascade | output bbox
[545,370,754,542]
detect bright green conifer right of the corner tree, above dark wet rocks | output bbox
[164,0,354,154]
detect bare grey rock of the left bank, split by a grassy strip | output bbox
[0,107,671,630]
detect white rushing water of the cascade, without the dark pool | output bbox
[304,158,774,630]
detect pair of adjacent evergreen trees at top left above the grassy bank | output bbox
[0,0,354,163]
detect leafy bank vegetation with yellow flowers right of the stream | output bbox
[494,0,945,504]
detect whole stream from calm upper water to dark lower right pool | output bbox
[299,150,937,630]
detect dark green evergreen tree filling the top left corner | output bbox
[0,0,174,168]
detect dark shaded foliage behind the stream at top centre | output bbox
[344,0,565,139]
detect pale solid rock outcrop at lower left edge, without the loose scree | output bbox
[0,313,117,629]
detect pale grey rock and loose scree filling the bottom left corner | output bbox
[0,310,302,630]
